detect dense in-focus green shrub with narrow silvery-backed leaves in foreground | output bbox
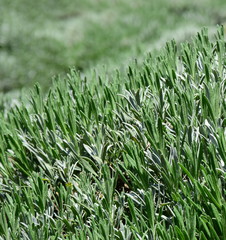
[0,28,226,240]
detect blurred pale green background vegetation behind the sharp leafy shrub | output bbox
[0,0,226,93]
